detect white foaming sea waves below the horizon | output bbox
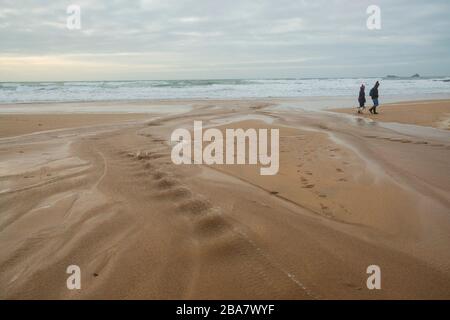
[0,77,450,104]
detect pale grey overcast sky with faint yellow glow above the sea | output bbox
[0,0,450,81]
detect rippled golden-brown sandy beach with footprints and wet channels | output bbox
[0,99,450,299]
